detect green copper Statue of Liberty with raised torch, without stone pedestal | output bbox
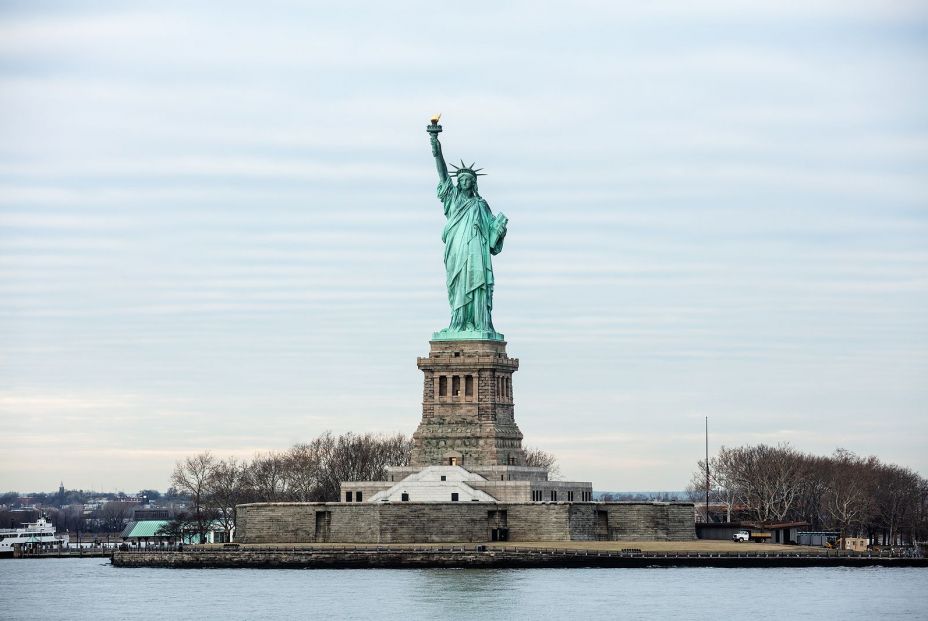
[427,115,509,340]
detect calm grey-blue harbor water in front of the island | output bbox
[0,559,928,621]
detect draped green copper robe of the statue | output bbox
[438,178,506,332]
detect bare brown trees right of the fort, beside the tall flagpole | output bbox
[688,444,928,544]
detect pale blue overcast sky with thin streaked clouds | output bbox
[0,0,928,492]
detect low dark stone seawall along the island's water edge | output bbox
[112,545,928,569]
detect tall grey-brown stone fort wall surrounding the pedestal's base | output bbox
[235,502,696,544]
